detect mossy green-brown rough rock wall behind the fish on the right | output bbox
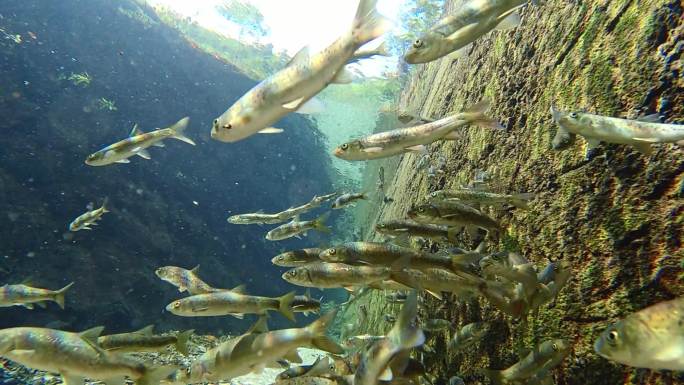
[349,0,684,385]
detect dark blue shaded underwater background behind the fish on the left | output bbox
[0,0,340,332]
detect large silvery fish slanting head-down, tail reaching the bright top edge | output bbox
[211,0,389,142]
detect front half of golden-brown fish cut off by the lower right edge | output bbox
[594,297,684,371]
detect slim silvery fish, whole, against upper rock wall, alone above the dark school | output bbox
[333,100,503,161]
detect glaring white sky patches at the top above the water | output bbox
[148,0,403,76]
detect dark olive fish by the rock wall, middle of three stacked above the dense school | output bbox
[407,201,503,234]
